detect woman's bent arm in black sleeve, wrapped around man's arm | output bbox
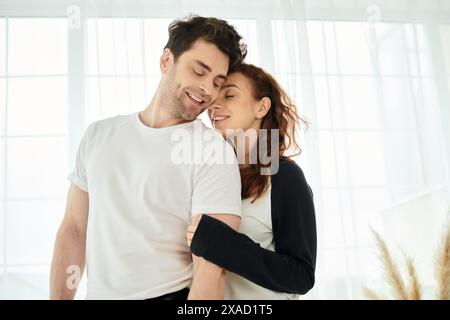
[191,162,317,294]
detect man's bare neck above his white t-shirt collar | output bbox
[139,92,187,128]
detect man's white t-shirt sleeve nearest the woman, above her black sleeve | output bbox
[191,138,241,216]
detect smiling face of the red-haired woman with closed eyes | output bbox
[208,72,267,135]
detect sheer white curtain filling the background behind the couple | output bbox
[0,0,450,299]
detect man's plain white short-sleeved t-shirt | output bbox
[69,112,241,299]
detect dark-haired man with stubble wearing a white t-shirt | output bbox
[51,17,246,299]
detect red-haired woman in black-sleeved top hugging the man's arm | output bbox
[187,64,317,299]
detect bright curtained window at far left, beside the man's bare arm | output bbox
[0,18,68,298]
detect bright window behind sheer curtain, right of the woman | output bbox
[272,20,450,299]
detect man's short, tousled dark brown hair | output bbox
[164,16,247,72]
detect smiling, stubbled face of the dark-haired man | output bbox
[161,39,229,121]
